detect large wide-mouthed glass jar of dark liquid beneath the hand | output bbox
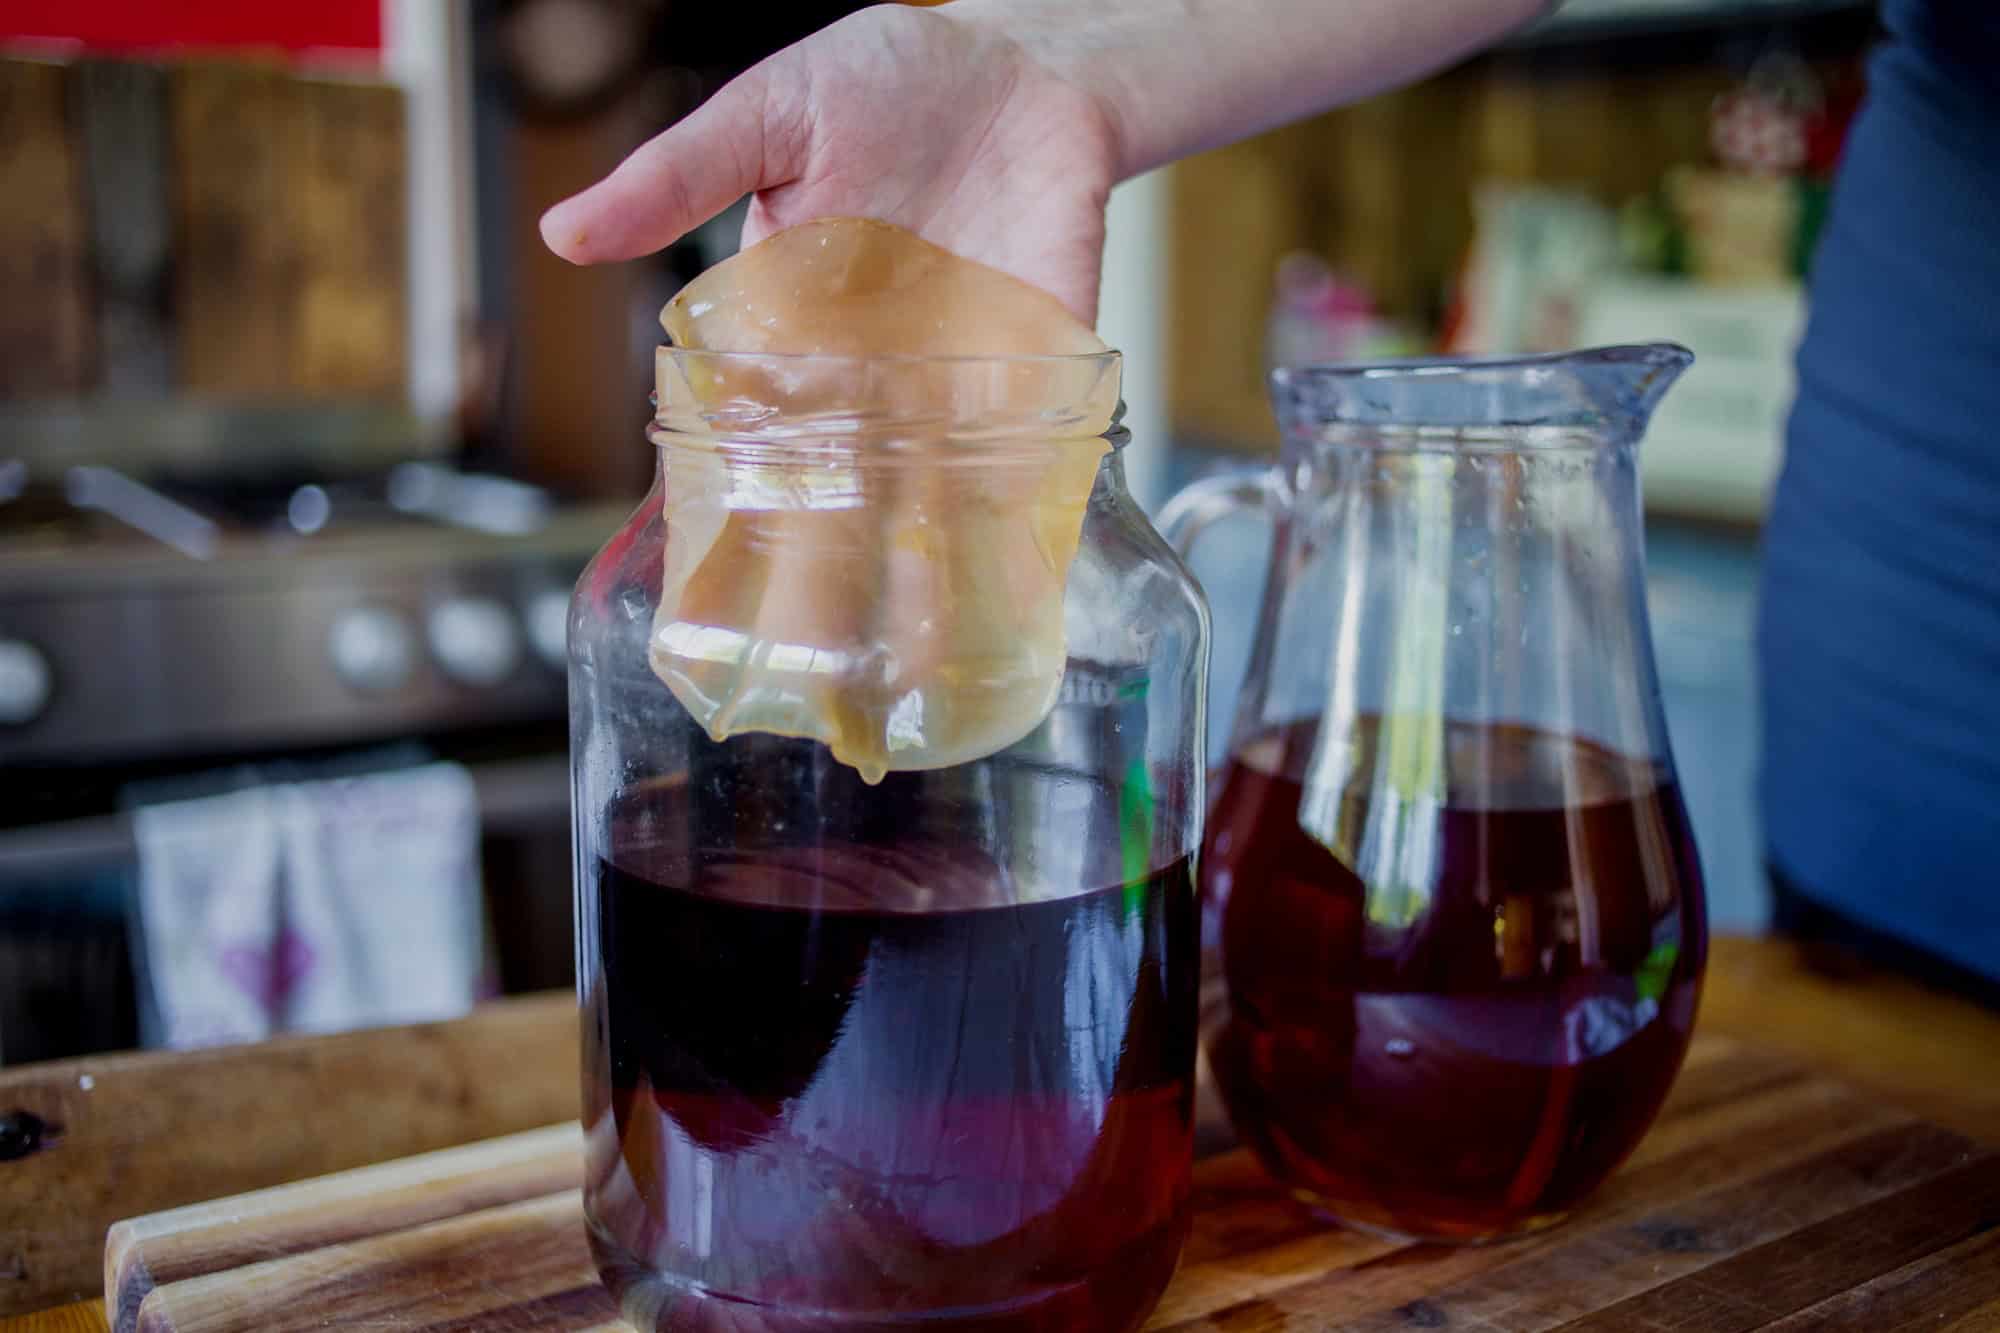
[570,350,1208,1331]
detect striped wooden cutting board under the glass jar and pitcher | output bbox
[104,1037,2000,1333]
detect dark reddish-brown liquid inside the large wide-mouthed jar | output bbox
[582,739,1198,1333]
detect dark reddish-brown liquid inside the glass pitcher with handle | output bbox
[1202,721,1706,1239]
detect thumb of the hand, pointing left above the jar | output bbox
[542,62,804,264]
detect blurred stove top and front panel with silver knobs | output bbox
[0,462,630,767]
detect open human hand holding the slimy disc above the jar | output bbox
[542,0,1120,324]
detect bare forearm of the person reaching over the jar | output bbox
[946,0,1550,176]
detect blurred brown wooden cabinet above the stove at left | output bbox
[0,58,408,402]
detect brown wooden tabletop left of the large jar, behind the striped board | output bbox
[0,995,578,1315]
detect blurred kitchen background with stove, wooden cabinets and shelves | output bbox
[0,0,1876,1063]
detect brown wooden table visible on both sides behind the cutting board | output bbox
[0,939,2000,1333]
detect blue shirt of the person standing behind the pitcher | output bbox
[1760,0,2000,979]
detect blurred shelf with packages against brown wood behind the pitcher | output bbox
[1166,13,1870,524]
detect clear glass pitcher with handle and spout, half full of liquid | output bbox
[1162,344,1706,1241]
